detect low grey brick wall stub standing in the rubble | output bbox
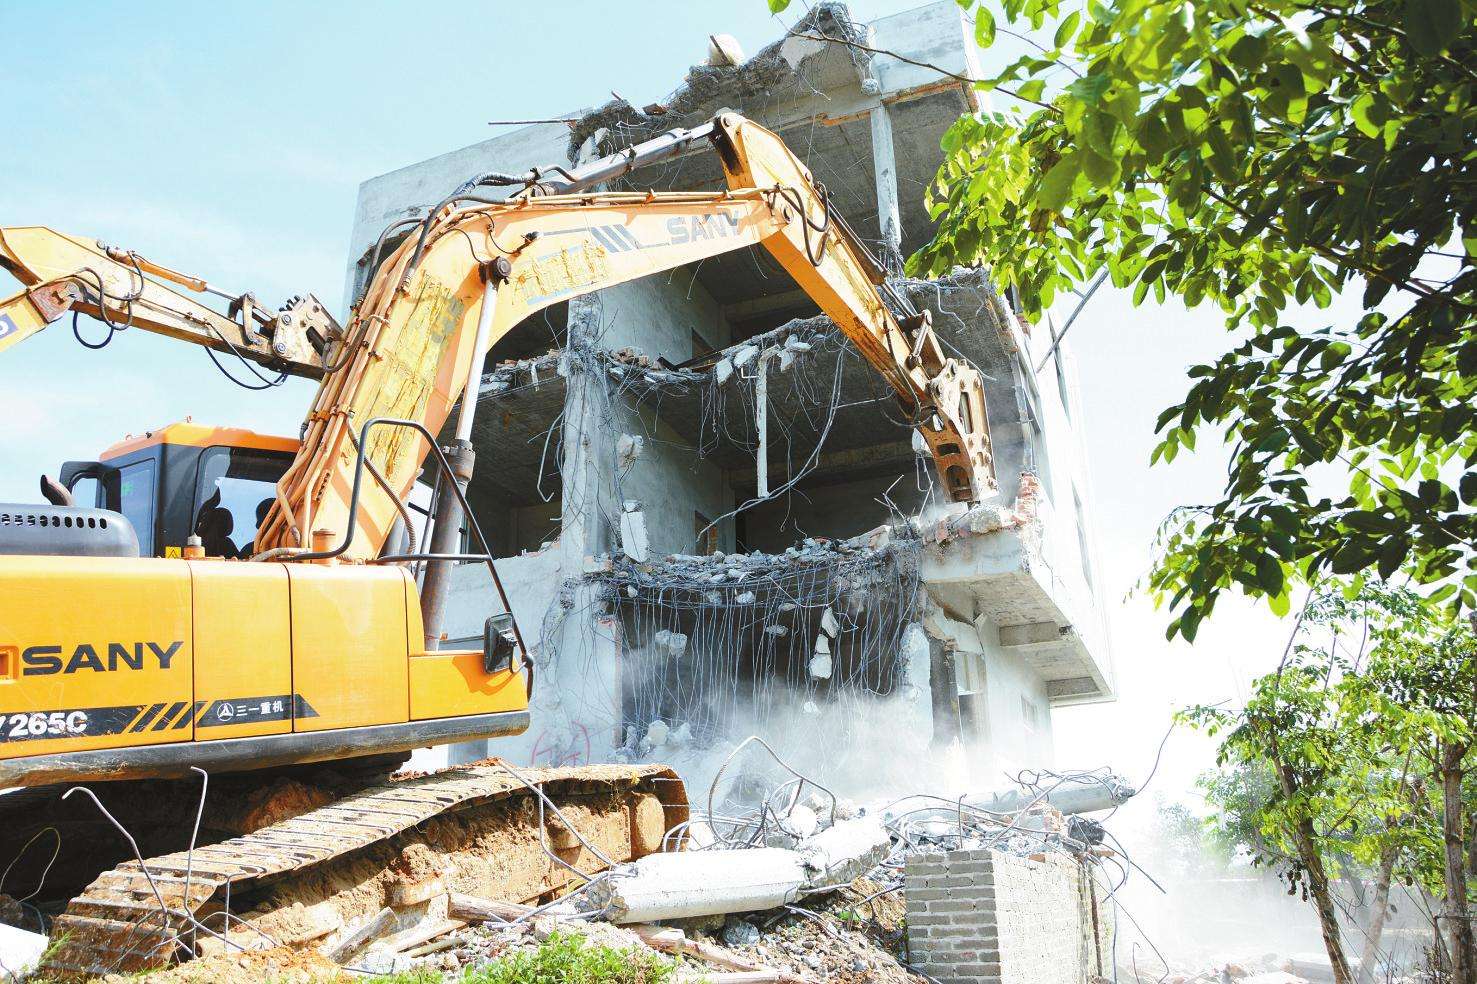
[902,851,1112,984]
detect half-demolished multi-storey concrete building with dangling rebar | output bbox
[346,0,1112,780]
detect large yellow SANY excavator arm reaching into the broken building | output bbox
[257,114,994,560]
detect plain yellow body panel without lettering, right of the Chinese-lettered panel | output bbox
[287,564,419,731]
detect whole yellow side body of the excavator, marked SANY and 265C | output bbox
[0,546,527,785]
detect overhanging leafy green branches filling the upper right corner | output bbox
[770,0,1477,638]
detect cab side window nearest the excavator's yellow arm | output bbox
[193,448,292,557]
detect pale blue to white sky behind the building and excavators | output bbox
[0,0,1317,815]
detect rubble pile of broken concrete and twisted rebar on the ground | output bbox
[0,756,1140,984]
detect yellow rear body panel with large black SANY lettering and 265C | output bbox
[0,557,195,759]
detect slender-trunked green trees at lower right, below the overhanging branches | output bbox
[1186,584,1477,984]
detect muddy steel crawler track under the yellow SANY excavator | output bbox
[40,761,687,980]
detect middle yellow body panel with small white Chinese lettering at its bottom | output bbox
[189,560,294,742]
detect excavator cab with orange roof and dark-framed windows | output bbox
[58,421,298,558]
